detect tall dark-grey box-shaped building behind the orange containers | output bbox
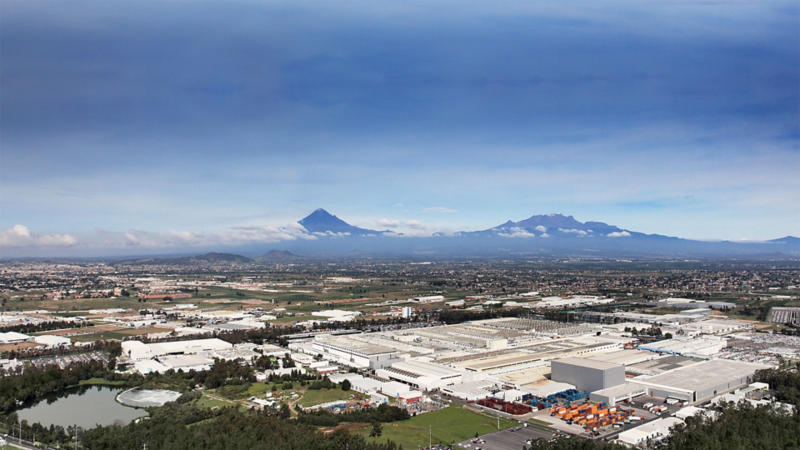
[550,358,625,391]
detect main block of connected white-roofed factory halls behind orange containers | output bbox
[282,318,770,403]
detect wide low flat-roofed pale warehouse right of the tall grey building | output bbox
[629,359,769,402]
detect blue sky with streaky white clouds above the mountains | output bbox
[0,0,800,255]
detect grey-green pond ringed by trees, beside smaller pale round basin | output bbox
[17,386,147,428]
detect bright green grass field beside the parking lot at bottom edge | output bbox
[358,406,518,449]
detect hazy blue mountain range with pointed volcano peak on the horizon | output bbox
[272,208,800,259]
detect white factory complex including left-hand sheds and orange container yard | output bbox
[114,315,788,446]
